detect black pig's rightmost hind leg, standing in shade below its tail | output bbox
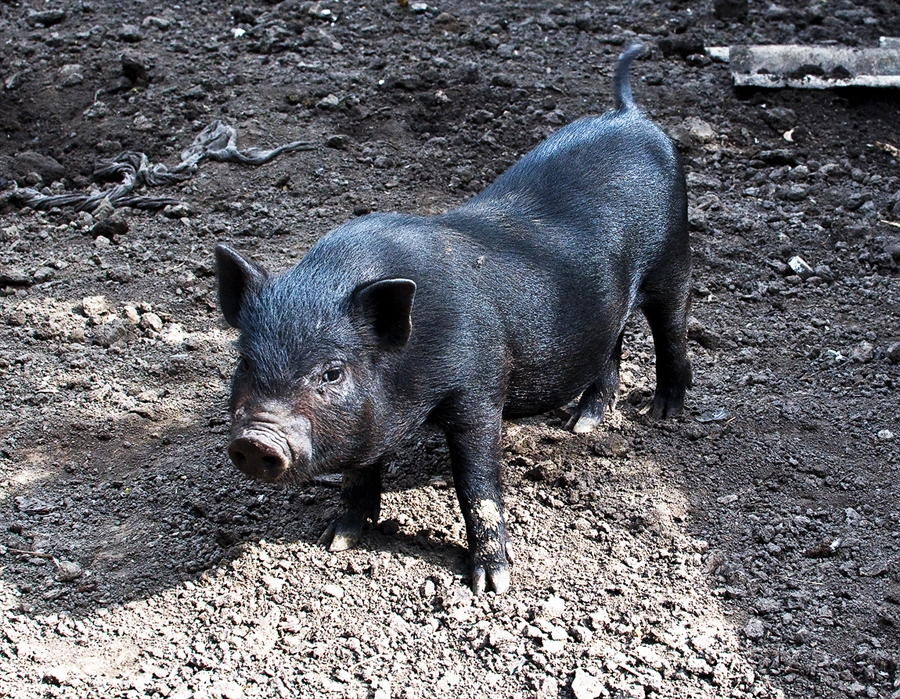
[642,295,692,418]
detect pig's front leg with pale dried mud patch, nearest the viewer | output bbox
[447,415,512,595]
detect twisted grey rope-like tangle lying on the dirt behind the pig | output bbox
[10,119,316,212]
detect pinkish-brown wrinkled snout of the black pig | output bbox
[228,411,312,481]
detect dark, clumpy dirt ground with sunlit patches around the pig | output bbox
[0,0,900,699]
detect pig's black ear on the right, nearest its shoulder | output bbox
[353,279,416,349]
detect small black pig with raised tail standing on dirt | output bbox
[216,46,691,593]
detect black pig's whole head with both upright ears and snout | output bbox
[216,245,416,481]
